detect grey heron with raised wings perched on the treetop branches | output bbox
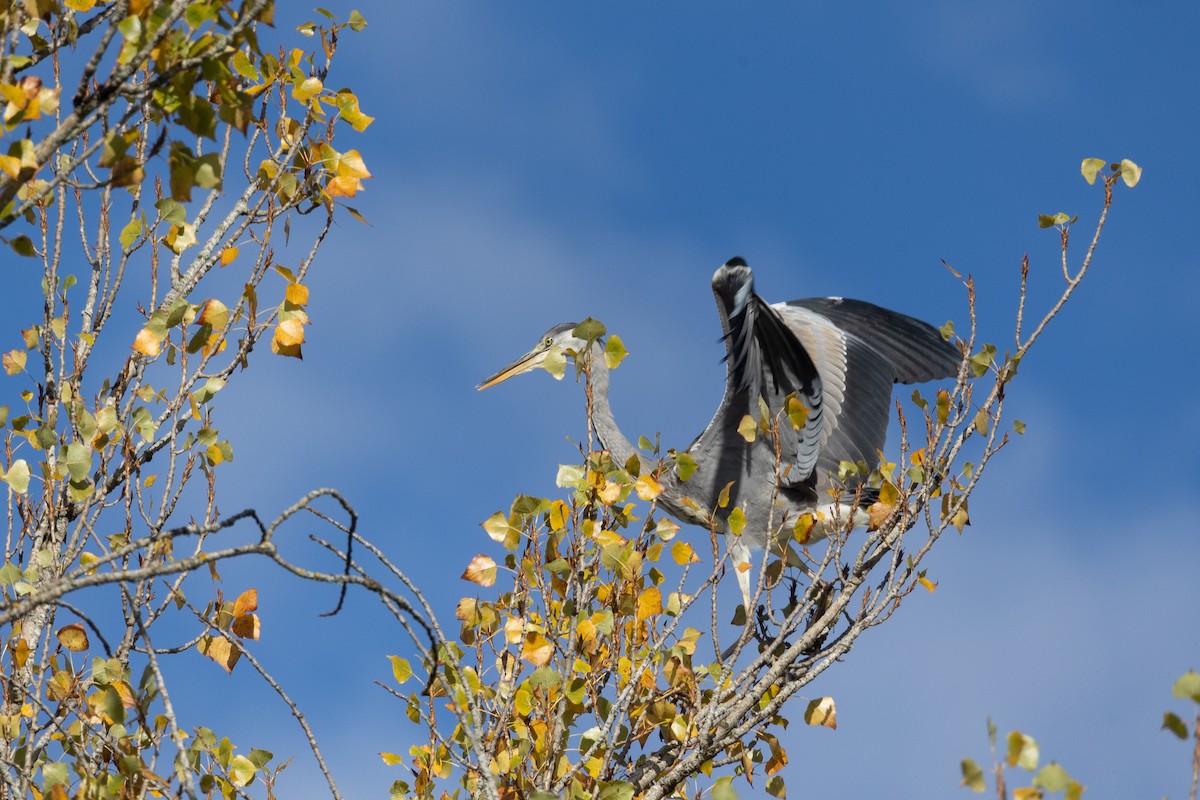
[476,258,962,613]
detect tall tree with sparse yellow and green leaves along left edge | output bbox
[0,0,372,798]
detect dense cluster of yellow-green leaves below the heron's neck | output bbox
[385,443,835,799]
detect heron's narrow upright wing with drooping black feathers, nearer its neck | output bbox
[713,258,824,486]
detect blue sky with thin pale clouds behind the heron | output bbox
[16,1,1200,799]
